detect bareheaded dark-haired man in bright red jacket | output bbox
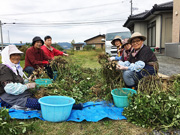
[41,36,69,59]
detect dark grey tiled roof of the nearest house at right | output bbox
[123,1,173,27]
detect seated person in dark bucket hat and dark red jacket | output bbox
[24,36,52,78]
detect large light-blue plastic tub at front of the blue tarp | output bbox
[38,96,75,122]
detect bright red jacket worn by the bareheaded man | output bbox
[41,45,63,59]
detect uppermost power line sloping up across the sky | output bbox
[0,0,125,16]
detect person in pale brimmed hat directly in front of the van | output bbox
[109,36,123,61]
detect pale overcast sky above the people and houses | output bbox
[0,0,172,43]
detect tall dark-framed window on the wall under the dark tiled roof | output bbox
[147,22,156,47]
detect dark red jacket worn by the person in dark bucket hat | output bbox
[24,46,52,69]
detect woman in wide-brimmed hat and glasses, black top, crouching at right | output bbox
[117,32,158,88]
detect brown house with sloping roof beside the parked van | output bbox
[84,34,105,49]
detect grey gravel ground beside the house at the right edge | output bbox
[156,54,180,76]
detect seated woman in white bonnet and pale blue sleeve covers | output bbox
[0,45,40,110]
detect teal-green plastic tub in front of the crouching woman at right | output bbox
[111,88,136,108]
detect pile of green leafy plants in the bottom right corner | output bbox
[123,88,180,129]
